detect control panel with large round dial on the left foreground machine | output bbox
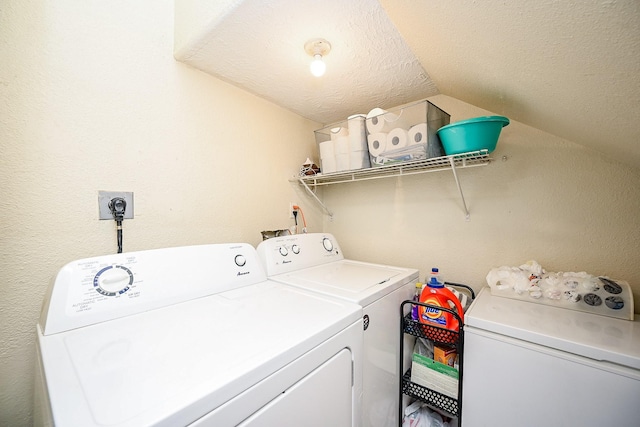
[40,243,266,335]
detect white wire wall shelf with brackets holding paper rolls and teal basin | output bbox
[291,150,491,221]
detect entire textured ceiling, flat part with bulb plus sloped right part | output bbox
[174,0,640,168]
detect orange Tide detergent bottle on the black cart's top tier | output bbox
[418,277,464,332]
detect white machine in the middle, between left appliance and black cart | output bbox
[257,233,418,427]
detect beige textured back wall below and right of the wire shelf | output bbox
[323,95,640,312]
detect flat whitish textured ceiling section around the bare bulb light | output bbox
[175,0,438,124]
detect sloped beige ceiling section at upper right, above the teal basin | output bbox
[381,0,640,168]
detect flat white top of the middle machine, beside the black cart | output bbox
[270,259,418,307]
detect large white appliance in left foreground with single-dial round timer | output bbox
[34,244,362,427]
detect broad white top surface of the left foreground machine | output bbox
[38,281,362,427]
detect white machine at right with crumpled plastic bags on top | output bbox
[462,285,640,427]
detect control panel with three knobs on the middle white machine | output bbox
[257,233,344,276]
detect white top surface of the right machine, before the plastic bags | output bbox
[464,288,640,369]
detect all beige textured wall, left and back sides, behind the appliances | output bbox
[5,0,640,426]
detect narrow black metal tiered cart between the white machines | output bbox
[398,282,476,427]
